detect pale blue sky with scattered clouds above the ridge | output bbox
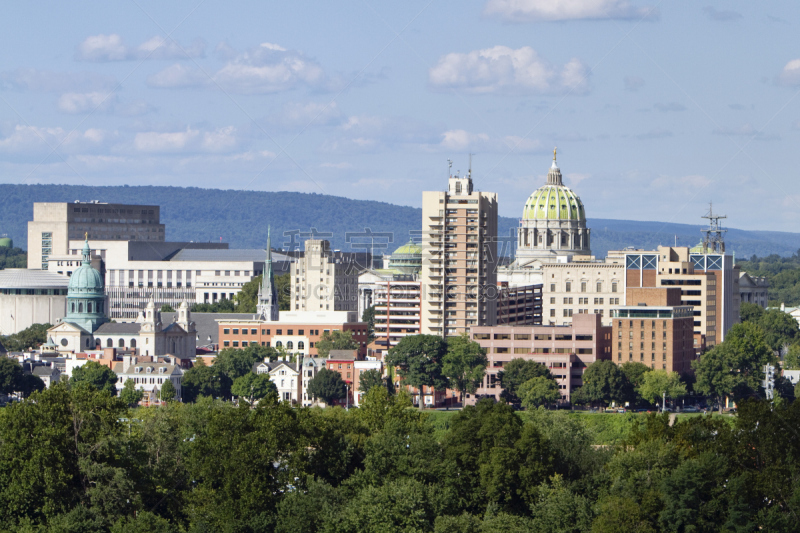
[0,0,800,232]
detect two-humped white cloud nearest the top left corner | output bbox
[75,33,206,62]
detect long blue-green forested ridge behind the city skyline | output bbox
[0,184,800,258]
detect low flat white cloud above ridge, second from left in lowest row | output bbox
[133,126,238,153]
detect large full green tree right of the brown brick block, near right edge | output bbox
[692,322,775,412]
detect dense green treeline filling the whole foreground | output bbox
[0,385,800,533]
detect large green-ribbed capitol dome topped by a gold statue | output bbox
[517,150,591,263]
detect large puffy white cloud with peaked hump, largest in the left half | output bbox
[147,43,327,94]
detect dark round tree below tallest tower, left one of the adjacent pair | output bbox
[385,335,447,409]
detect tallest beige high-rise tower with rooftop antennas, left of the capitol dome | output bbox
[420,166,498,336]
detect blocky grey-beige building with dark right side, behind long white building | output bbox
[28,201,164,270]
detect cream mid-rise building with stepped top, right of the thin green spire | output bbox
[291,239,358,311]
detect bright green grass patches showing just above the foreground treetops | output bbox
[427,411,735,445]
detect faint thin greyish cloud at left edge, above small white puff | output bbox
[0,68,117,92]
